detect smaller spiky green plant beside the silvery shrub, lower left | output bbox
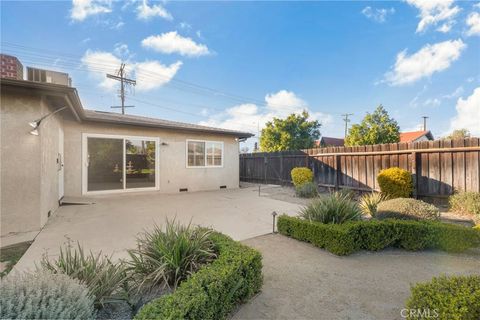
[40,243,127,307]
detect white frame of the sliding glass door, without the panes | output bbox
[82,133,160,195]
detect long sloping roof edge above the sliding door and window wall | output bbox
[82,109,253,138]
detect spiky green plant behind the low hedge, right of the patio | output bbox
[300,192,362,223]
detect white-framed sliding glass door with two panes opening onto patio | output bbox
[83,134,158,194]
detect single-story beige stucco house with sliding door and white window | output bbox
[0,79,252,240]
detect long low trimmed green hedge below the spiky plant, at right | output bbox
[277,215,480,255]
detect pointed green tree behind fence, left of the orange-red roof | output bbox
[345,105,400,146]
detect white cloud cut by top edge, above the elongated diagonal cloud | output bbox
[406,0,461,32]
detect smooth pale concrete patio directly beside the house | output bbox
[15,188,299,270]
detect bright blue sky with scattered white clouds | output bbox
[1,0,480,148]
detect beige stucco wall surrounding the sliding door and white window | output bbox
[64,121,239,196]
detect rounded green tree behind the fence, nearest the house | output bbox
[260,111,321,152]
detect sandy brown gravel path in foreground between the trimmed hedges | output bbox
[233,235,480,320]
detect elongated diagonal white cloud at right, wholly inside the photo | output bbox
[385,39,467,86]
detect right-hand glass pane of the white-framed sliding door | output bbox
[125,139,155,188]
